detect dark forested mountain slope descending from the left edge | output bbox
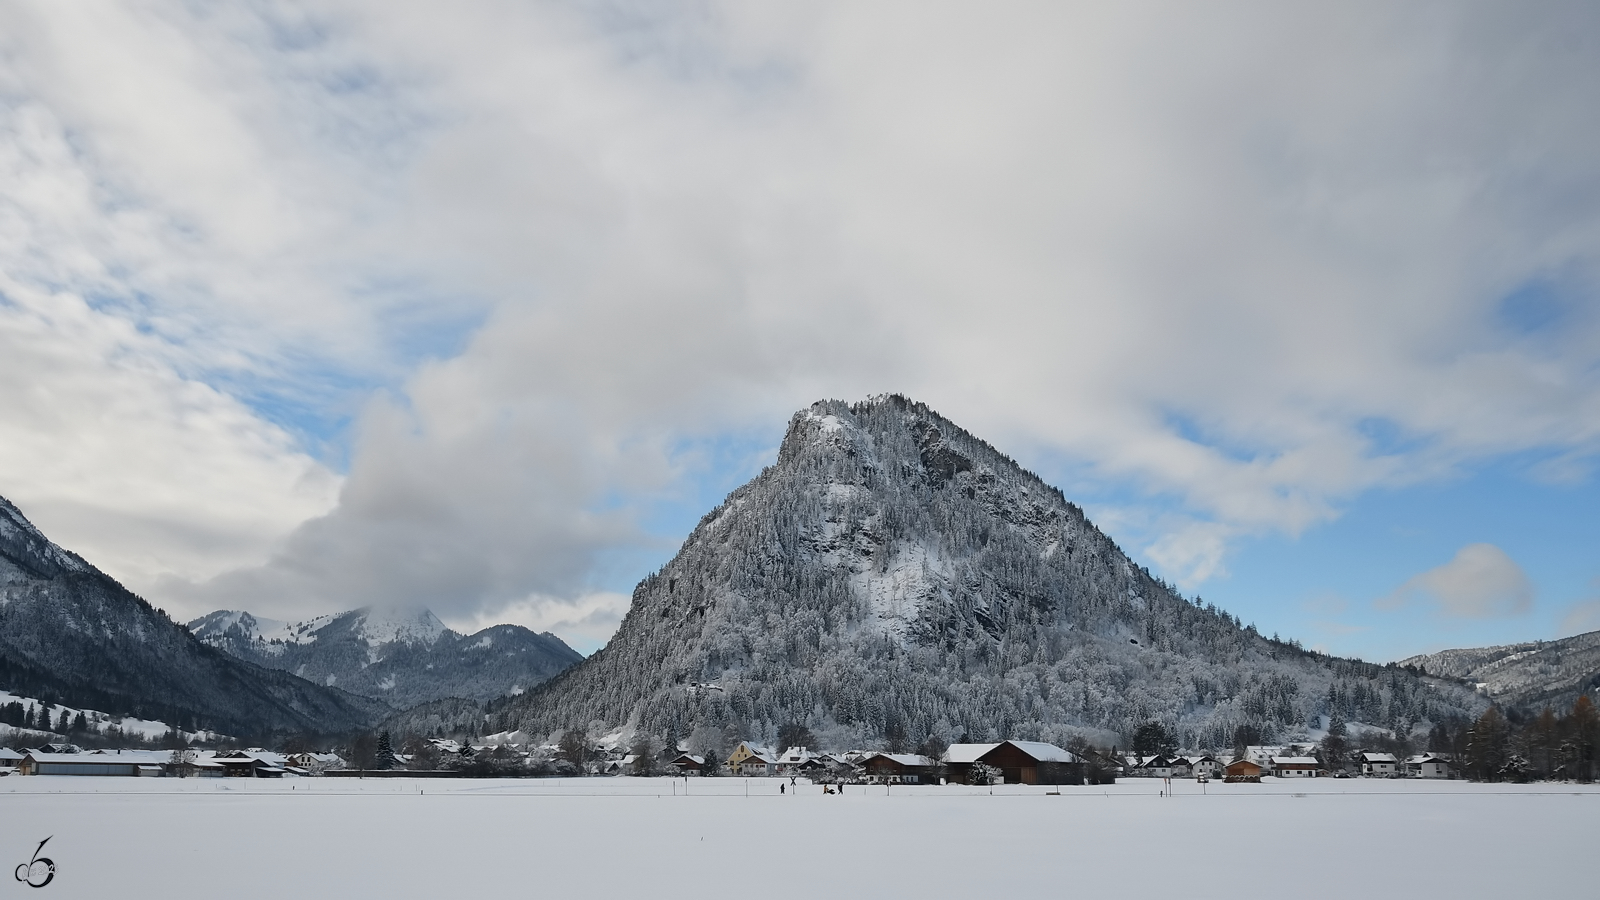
[0,498,390,737]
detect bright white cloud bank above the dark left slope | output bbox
[0,277,339,594]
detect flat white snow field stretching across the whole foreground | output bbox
[0,775,1600,900]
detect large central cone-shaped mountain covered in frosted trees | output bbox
[491,396,1486,748]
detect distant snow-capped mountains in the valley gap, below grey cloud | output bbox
[189,607,582,709]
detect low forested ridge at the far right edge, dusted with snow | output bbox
[1400,631,1600,713]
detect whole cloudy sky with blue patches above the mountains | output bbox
[0,0,1600,660]
